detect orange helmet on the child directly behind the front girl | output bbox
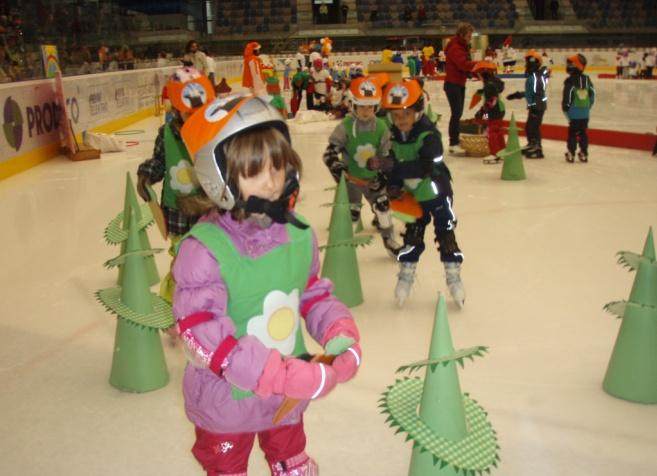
[166,66,215,112]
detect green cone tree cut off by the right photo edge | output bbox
[603,228,657,403]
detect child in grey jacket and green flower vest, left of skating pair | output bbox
[323,77,400,257]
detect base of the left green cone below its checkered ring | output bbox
[109,317,169,393]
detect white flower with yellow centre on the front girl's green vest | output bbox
[246,289,301,355]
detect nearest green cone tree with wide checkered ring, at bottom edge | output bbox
[379,296,499,476]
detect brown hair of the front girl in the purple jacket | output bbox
[178,126,302,219]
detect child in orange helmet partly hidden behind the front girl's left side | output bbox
[137,66,215,302]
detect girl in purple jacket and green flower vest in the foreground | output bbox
[173,96,360,476]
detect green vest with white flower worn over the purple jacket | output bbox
[182,218,313,400]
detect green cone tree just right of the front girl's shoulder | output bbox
[321,174,372,307]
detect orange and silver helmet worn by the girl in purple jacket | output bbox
[180,94,290,210]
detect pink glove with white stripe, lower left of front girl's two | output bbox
[255,350,338,400]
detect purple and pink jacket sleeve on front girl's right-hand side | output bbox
[301,234,353,345]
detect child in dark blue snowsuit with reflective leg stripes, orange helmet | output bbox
[382,79,465,306]
